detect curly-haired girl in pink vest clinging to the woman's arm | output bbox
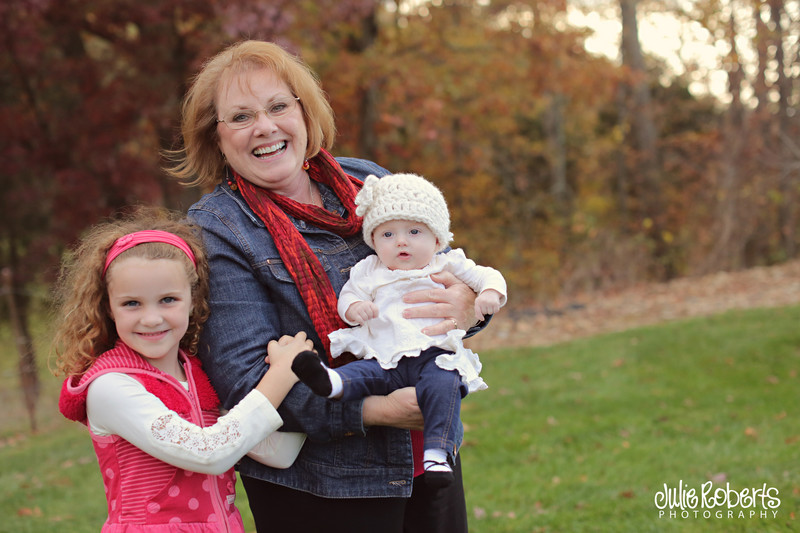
[55,210,312,533]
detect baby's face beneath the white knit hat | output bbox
[372,220,439,270]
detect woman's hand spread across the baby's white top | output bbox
[403,272,477,335]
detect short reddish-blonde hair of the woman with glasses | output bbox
[165,41,336,189]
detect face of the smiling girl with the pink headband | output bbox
[106,257,192,379]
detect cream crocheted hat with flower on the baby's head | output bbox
[356,174,453,252]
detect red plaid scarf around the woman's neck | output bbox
[231,150,362,366]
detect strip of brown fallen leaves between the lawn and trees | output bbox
[466,260,800,352]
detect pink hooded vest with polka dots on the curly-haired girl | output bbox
[59,342,244,533]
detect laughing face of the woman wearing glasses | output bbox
[216,69,308,196]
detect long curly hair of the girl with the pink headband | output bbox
[53,207,209,376]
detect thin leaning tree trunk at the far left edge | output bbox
[2,267,39,432]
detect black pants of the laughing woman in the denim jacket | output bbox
[241,456,467,533]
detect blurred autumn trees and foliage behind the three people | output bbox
[0,0,800,427]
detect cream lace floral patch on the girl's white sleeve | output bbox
[150,413,242,456]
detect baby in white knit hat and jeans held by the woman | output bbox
[292,174,506,486]
